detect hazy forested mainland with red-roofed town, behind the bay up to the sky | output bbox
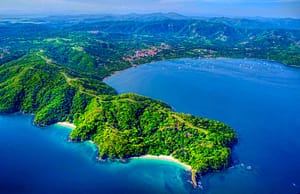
[0,14,300,79]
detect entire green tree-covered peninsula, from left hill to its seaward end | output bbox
[0,52,237,178]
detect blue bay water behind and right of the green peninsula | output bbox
[106,59,300,194]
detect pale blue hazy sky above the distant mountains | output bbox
[0,0,300,18]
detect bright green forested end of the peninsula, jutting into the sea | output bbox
[70,94,237,172]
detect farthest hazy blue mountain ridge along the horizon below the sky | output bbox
[0,12,300,30]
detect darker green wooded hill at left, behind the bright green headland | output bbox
[0,54,116,125]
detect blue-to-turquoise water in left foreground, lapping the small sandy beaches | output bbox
[0,114,192,194]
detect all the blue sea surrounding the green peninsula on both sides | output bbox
[0,59,300,194]
